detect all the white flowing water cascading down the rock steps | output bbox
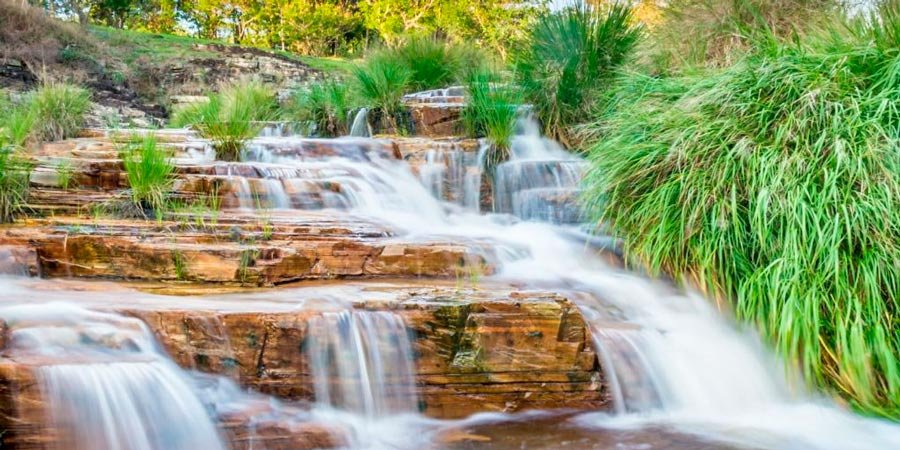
[0,119,900,450]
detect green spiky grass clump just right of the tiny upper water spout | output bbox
[353,54,412,131]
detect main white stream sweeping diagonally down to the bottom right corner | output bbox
[230,121,900,449]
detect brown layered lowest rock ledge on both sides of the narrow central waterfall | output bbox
[121,285,608,418]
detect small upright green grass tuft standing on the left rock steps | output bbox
[121,135,175,214]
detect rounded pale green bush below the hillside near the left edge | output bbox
[26,83,91,141]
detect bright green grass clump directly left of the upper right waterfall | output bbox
[462,71,522,175]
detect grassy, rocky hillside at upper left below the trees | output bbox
[0,0,349,123]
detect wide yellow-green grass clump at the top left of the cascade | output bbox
[172,80,280,161]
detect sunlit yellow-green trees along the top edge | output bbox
[35,0,545,56]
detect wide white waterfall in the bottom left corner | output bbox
[0,304,225,450]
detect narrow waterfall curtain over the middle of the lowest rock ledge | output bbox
[306,311,418,418]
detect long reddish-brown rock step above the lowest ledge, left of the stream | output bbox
[0,220,493,286]
